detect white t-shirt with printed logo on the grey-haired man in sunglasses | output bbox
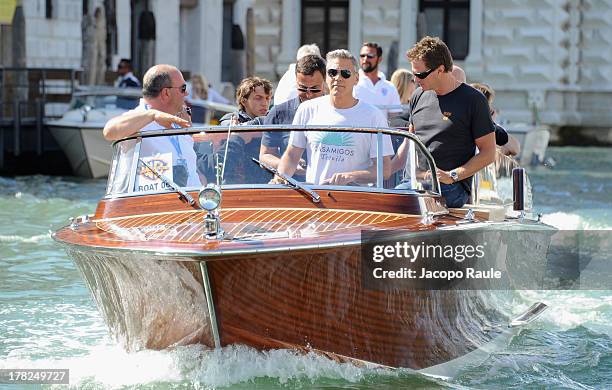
[289,96,393,184]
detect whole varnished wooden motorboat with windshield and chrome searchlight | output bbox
[54,126,551,376]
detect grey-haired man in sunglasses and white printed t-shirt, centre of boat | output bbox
[273,50,393,185]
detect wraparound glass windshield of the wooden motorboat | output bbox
[107,126,439,197]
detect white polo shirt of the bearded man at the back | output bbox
[353,70,403,115]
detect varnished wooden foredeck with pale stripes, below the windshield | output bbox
[57,189,461,255]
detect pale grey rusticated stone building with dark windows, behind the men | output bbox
[255,0,612,134]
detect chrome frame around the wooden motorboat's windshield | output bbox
[105,125,441,198]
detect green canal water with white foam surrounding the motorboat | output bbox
[0,148,612,389]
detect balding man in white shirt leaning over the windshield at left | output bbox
[103,65,200,191]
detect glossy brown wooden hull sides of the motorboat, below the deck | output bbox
[64,242,504,369]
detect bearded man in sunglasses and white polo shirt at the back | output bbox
[353,42,402,118]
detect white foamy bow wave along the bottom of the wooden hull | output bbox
[0,344,382,388]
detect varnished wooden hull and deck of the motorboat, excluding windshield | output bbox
[55,189,552,369]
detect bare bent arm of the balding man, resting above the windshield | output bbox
[102,109,191,141]
